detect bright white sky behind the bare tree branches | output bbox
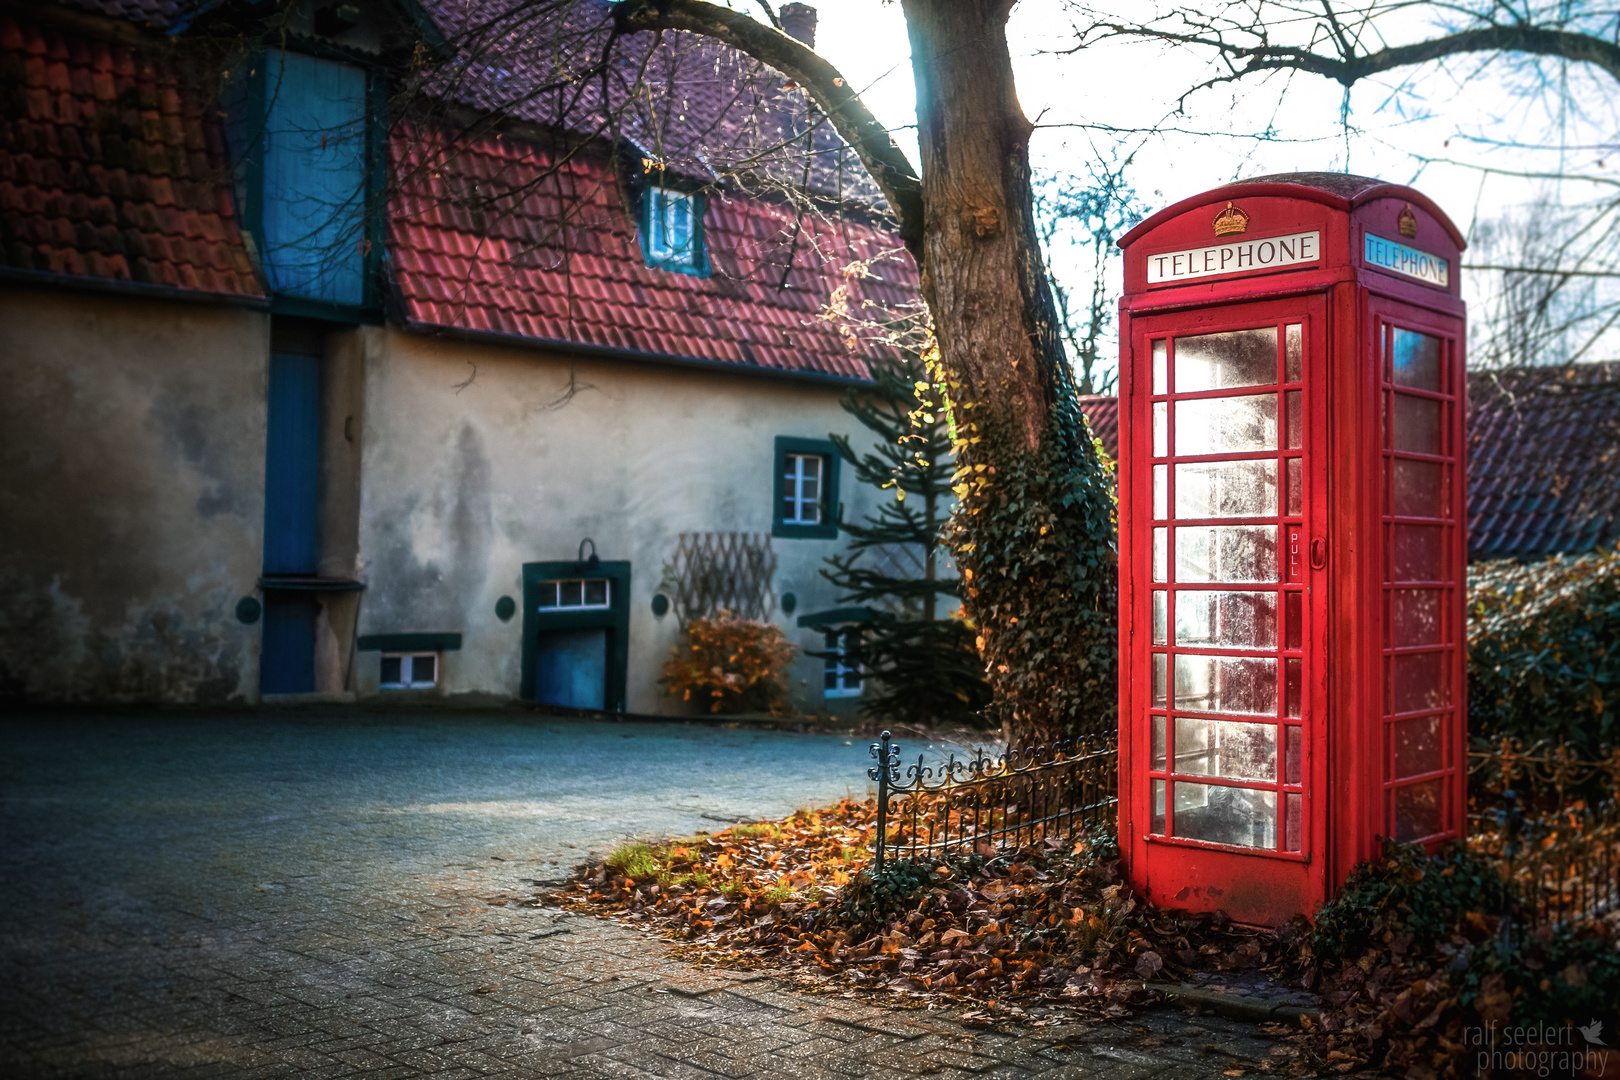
[751,0,1620,386]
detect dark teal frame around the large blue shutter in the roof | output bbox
[237,42,387,317]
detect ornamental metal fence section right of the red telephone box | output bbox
[1468,740,1620,928]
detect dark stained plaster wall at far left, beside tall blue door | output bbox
[0,288,269,703]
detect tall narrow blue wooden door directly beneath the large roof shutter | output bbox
[264,353,321,575]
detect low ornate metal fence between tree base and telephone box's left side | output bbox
[867,732,1119,870]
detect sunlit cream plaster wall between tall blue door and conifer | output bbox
[356,327,870,712]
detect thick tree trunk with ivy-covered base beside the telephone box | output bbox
[902,0,1118,745]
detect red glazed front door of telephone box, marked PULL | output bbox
[1121,295,1328,923]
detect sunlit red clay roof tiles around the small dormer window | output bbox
[389,120,915,379]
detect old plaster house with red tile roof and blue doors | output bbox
[0,0,919,712]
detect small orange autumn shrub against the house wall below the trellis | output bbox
[659,610,797,712]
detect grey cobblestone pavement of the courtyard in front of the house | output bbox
[0,714,1289,1080]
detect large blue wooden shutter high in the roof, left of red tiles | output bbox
[249,49,373,304]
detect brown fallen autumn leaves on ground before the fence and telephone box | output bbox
[548,798,1366,1075]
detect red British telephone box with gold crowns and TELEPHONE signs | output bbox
[1119,173,1466,925]
